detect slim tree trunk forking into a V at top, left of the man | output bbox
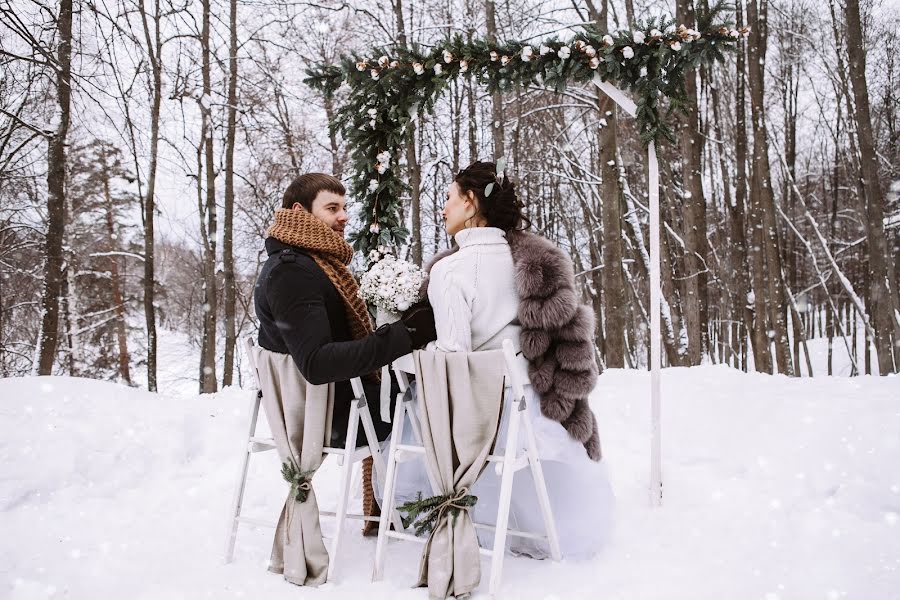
[138,0,162,392]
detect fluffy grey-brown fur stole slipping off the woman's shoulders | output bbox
[422,232,601,460]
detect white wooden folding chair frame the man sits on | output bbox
[225,337,390,581]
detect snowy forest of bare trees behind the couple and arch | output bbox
[0,0,900,392]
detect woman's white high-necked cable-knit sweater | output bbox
[428,227,521,352]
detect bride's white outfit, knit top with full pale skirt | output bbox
[375,227,615,558]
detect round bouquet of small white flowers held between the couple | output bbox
[357,252,425,313]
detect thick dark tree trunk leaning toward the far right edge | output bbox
[846,0,900,375]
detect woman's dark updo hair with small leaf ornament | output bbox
[453,161,531,232]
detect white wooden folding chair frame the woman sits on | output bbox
[372,340,562,597]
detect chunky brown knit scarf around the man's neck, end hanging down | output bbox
[266,208,381,535]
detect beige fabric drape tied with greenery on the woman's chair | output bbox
[414,350,504,600]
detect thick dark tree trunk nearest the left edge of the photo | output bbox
[38,0,72,375]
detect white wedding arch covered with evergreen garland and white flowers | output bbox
[305,8,749,506]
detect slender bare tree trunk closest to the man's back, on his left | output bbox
[222,0,238,386]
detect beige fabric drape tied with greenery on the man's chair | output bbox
[254,347,334,586]
